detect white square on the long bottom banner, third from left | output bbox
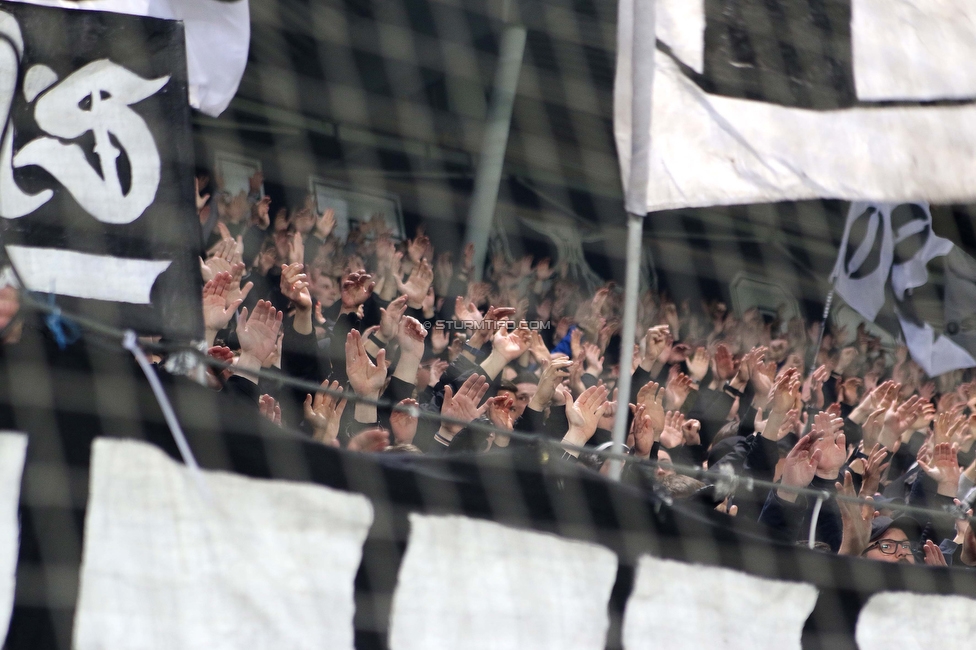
[390,514,617,650]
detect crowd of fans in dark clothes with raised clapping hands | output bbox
[181,176,976,567]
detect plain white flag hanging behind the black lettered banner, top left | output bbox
[7,0,251,117]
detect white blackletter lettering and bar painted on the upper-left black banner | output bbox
[0,13,169,304]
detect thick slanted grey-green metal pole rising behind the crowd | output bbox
[464,19,526,281]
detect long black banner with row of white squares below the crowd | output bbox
[0,342,976,650]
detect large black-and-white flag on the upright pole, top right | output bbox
[614,0,976,214]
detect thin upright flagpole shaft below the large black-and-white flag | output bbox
[610,214,644,481]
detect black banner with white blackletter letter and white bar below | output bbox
[0,3,202,338]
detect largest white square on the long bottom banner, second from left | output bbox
[73,438,373,650]
